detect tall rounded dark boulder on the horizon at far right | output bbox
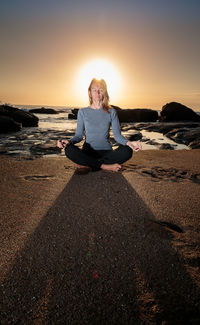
[160,102,200,122]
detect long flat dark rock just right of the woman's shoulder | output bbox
[117,108,158,123]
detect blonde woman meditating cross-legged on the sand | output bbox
[57,78,142,173]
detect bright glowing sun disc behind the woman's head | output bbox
[76,59,122,104]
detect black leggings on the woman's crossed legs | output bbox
[65,142,133,171]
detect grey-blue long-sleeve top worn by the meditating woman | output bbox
[70,106,128,150]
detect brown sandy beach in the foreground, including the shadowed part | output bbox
[0,149,200,324]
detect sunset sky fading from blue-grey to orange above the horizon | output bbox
[0,0,200,110]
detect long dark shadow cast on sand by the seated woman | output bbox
[0,171,200,325]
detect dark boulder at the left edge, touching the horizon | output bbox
[0,105,39,126]
